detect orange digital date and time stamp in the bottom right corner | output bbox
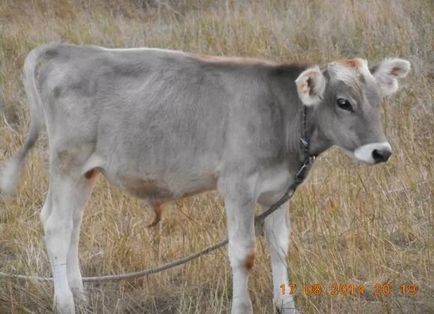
[280,282,419,298]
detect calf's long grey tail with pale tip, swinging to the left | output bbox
[0,46,46,196]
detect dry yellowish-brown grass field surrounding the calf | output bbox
[0,0,434,313]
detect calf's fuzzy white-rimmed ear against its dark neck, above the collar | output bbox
[295,65,326,106]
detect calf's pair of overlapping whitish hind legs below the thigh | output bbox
[41,171,91,313]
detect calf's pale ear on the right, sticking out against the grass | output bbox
[371,58,411,96]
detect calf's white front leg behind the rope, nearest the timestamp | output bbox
[264,202,297,314]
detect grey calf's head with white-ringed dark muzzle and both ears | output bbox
[295,58,410,164]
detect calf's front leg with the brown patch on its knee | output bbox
[219,178,255,314]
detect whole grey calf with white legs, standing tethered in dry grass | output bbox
[0,44,410,313]
